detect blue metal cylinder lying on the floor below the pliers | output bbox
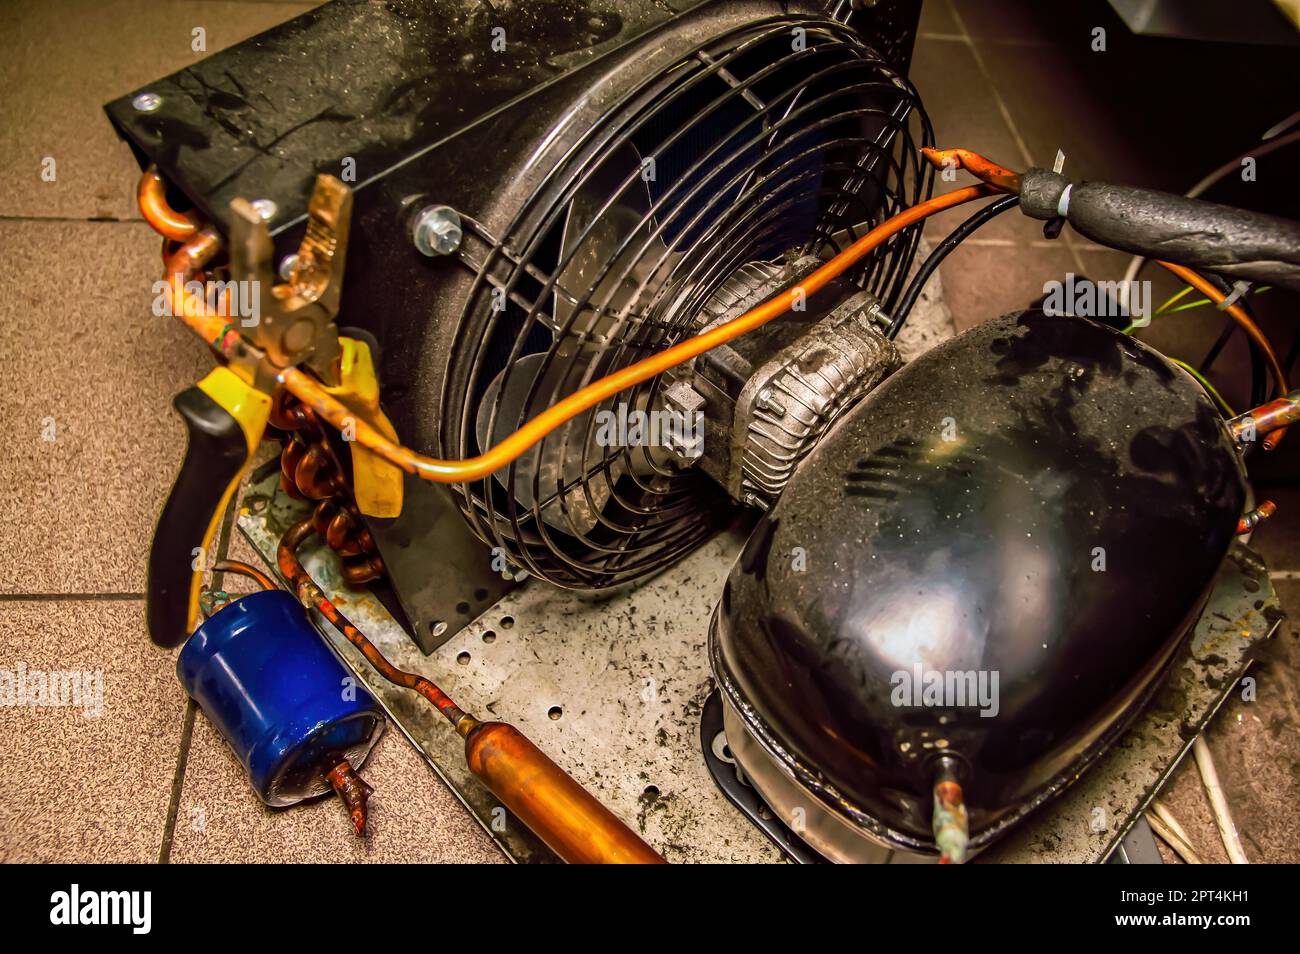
[176,590,385,806]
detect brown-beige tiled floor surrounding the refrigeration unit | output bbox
[0,0,1300,862]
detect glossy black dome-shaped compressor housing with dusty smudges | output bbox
[711,312,1245,850]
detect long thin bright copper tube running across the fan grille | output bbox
[154,185,995,483]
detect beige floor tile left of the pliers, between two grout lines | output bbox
[0,222,212,594]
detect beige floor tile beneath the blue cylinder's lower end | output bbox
[170,690,504,864]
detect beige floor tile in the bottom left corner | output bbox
[0,600,183,862]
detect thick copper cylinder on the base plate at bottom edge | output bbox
[462,723,666,864]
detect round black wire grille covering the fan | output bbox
[441,17,933,589]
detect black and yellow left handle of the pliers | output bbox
[146,386,248,649]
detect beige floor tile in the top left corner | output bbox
[0,0,315,218]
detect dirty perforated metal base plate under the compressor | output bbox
[239,474,1282,863]
